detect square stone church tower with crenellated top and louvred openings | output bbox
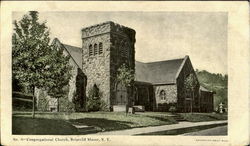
[82,21,135,107]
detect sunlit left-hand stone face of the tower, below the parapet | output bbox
[82,33,110,105]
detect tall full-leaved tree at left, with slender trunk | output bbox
[12,11,70,118]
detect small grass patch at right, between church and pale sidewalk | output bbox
[179,113,227,122]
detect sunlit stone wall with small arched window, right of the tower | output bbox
[154,84,177,111]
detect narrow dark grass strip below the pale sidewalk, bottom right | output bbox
[138,124,226,135]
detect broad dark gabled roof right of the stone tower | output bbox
[135,56,187,84]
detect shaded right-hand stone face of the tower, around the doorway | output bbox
[110,25,135,105]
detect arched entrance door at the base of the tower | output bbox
[115,84,128,105]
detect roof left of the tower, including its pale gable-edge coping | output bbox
[52,38,82,69]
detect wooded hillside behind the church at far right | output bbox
[196,70,228,108]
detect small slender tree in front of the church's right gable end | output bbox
[184,73,199,113]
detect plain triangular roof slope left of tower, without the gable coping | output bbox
[63,44,82,68]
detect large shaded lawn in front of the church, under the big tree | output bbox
[13,112,177,134]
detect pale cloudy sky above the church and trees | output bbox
[12,11,228,74]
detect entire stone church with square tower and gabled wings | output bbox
[38,21,213,112]
